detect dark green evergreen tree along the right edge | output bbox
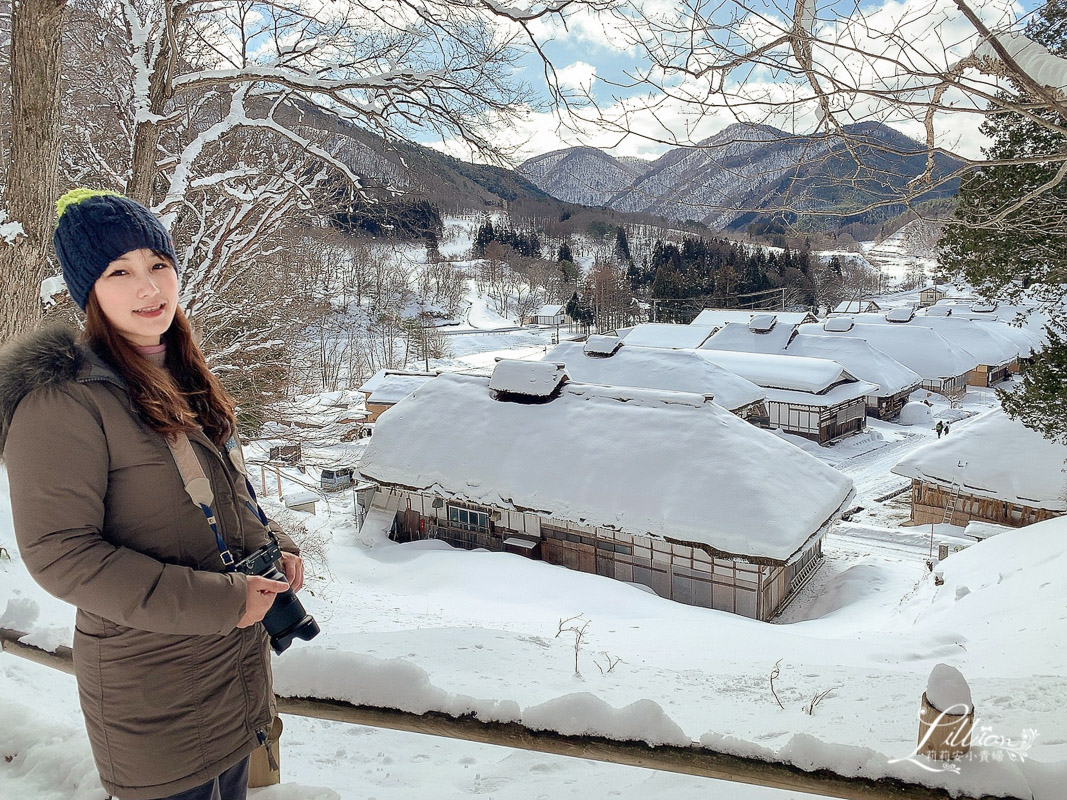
[939,0,1067,442]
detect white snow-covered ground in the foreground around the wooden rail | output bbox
[0,362,1067,800]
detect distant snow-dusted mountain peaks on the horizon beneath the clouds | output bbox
[519,123,961,230]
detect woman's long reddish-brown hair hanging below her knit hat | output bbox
[84,291,237,447]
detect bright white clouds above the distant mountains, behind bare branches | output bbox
[424,0,1023,161]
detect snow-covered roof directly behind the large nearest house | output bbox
[545,341,767,411]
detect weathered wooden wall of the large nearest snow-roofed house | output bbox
[379,490,822,620]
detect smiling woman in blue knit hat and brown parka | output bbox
[0,189,303,800]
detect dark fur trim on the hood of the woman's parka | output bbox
[0,324,124,458]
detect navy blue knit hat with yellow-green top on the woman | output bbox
[52,189,178,310]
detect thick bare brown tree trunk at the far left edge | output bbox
[0,0,66,343]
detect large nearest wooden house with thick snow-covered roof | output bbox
[361,361,854,620]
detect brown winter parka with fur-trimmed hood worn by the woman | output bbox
[0,327,298,800]
